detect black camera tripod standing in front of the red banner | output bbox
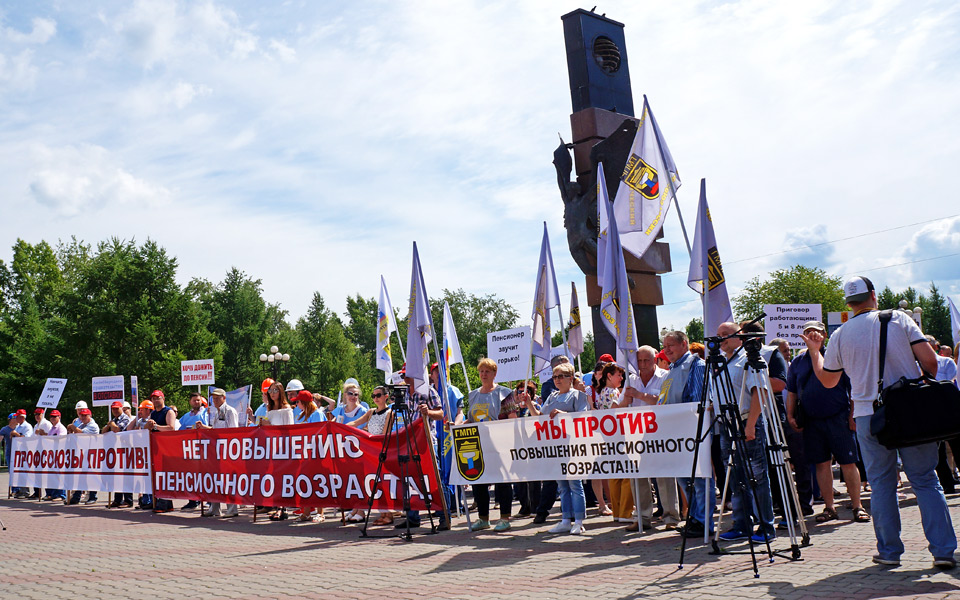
[360,386,442,542]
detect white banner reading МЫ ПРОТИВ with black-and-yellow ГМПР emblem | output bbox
[450,403,712,485]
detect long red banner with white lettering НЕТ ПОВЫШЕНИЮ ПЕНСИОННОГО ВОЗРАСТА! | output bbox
[150,419,442,510]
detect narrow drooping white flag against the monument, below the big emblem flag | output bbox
[597,165,640,369]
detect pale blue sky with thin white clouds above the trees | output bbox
[0,0,960,338]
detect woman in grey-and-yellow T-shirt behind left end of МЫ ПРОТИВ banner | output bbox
[466,358,517,531]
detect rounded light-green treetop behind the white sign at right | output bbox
[733,265,846,320]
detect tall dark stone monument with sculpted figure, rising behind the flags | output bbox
[553,9,671,356]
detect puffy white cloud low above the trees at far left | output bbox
[29,144,170,217]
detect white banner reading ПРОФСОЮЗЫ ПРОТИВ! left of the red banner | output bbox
[10,430,153,494]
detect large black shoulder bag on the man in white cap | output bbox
[870,310,960,450]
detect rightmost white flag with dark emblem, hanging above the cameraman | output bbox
[687,179,733,336]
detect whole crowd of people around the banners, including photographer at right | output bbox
[0,277,960,568]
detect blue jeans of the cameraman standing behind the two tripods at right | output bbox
[720,419,776,534]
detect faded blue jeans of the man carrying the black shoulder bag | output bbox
[855,416,957,559]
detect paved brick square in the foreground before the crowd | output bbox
[0,473,960,600]
